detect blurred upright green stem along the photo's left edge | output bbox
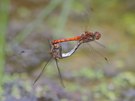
[0,0,9,98]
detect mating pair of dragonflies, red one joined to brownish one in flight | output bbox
[34,31,107,87]
